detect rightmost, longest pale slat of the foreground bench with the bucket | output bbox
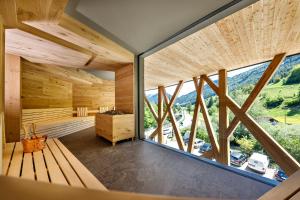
[54,139,107,190]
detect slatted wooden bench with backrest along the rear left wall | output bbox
[21,107,95,138]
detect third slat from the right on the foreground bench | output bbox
[43,147,68,185]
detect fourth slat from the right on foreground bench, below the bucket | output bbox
[33,151,49,182]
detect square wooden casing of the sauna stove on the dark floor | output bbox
[96,113,134,146]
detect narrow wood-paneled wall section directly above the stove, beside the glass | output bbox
[115,64,134,113]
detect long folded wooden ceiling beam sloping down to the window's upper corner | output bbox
[24,14,134,71]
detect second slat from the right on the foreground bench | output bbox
[47,139,83,187]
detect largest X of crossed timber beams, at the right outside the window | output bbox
[201,53,300,175]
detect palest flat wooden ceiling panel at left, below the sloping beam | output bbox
[5,29,90,68]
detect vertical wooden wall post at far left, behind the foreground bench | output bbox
[4,54,21,142]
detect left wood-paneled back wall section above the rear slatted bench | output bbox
[22,62,72,109]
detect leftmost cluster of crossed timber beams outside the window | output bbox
[144,81,184,151]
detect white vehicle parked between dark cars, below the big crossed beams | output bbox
[248,153,270,174]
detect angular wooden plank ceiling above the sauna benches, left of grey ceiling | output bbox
[0,0,134,71]
